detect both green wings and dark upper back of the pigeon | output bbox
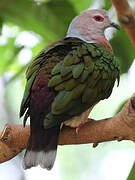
[20,38,119,128]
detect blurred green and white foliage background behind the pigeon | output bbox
[0,0,135,180]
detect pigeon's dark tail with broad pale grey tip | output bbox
[23,123,60,170]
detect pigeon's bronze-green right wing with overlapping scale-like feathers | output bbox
[46,42,119,124]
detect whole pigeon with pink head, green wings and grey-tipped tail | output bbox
[20,9,119,170]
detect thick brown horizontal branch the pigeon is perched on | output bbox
[0,94,135,163]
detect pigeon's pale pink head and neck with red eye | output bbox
[67,9,119,49]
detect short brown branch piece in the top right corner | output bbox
[112,0,135,48]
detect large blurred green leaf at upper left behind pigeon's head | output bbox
[1,0,76,43]
